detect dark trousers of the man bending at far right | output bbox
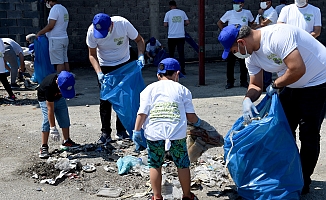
[280,83,326,186]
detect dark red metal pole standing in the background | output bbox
[198,0,205,85]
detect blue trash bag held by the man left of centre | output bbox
[100,61,147,150]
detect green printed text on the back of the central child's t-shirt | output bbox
[149,102,181,121]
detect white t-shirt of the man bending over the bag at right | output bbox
[246,24,326,88]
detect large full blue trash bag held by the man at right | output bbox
[224,94,303,200]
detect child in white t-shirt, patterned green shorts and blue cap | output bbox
[133,58,201,200]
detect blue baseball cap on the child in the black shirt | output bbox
[58,71,76,99]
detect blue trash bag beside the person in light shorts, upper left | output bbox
[31,35,56,83]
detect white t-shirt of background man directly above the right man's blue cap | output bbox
[220,9,254,26]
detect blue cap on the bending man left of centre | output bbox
[93,13,111,38]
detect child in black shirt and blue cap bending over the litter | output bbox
[37,71,80,158]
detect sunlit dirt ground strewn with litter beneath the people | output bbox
[0,62,326,200]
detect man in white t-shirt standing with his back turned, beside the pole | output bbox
[164,1,190,74]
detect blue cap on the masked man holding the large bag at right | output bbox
[218,24,241,59]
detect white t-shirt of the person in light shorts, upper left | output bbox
[46,4,69,38]
